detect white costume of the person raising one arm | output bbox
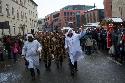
[65,29,85,65]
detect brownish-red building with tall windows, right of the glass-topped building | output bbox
[83,9,105,24]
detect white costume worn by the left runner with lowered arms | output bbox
[22,35,42,68]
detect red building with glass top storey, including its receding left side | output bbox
[45,5,94,30]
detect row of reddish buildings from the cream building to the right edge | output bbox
[39,0,125,31]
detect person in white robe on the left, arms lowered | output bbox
[22,34,42,80]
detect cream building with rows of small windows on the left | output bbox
[0,0,38,36]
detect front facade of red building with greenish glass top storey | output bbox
[60,5,95,28]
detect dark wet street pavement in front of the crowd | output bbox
[0,51,125,83]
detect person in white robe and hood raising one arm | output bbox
[65,29,85,76]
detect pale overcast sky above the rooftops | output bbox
[34,0,104,18]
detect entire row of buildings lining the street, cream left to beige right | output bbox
[0,0,125,36]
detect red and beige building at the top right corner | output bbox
[104,0,125,20]
